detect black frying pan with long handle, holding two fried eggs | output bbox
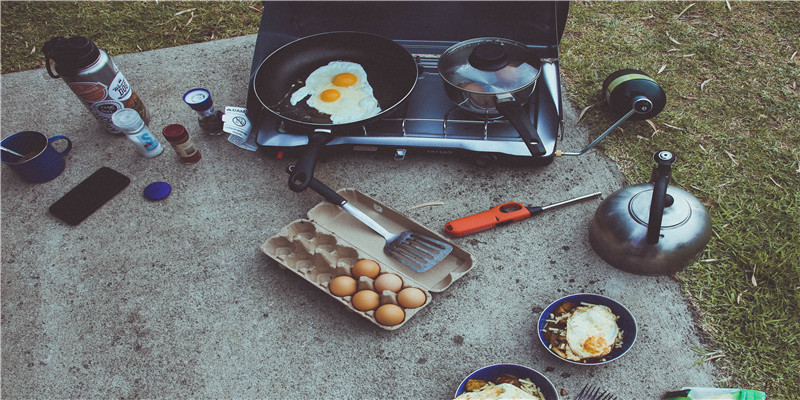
[253,32,417,192]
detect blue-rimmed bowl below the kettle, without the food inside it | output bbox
[537,293,636,365]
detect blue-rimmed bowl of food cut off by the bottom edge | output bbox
[454,364,558,400]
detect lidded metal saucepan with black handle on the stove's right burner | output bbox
[438,38,546,157]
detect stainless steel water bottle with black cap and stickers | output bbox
[42,36,150,135]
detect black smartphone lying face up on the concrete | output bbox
[49,167,131,225]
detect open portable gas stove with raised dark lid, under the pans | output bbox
[247,2,569,165]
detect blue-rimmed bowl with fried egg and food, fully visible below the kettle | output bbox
[538,293,636,365]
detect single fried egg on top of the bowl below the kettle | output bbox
[567,304,620,359]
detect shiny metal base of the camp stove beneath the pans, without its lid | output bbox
[254,40,561,165]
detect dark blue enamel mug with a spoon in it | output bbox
[0,131,72,183]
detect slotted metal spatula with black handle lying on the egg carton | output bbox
[296,170,453,273]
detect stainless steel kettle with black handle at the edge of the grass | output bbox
[589,151,711,275]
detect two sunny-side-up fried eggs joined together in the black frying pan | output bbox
[290,61,381,124]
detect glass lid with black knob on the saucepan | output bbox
[439,38,539,94]
